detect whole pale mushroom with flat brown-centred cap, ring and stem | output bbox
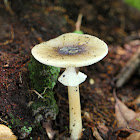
[32,33,108,140]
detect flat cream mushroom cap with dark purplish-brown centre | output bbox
[32,33,108,68]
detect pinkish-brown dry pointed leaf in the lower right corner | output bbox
[113,91,140,140]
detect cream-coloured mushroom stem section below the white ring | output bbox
[68,86,82,140]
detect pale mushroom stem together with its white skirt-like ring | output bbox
[58,67,87,140]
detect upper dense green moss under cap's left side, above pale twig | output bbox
[28,57,60,93]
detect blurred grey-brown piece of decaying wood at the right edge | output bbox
[116,45,140,87]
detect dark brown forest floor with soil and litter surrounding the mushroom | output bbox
[0,0,140,140]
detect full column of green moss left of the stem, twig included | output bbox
[28,57,60,119]
